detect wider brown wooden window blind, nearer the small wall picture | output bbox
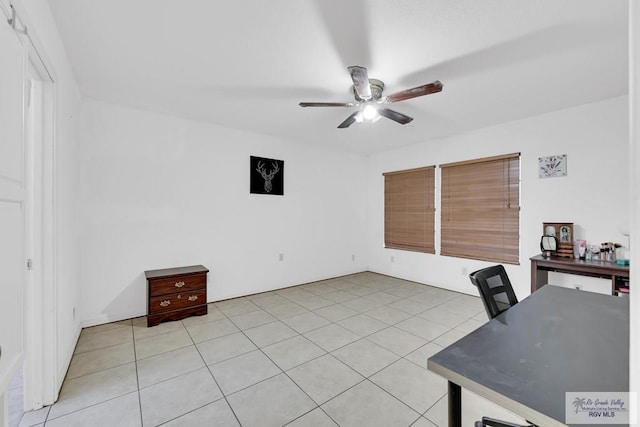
[440,153,520,264]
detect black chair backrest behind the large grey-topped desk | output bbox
[469,265,518,319]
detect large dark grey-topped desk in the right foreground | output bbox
[427,285,629,427]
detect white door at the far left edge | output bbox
[0,1,26,422]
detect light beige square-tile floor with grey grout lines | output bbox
[20,272,519,427]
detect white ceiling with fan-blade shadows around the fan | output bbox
[49,0,628,154]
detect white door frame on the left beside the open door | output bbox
[0,0,61,410]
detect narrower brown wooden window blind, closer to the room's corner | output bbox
[383,166,435,253]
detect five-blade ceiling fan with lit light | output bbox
[300,65,442,129]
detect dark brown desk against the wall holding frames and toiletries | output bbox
[530,255,629,295]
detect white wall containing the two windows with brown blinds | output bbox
[367,96,629,298]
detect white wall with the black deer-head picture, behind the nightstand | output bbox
[78,100,366,325]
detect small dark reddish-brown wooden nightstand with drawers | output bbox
[144,265,209,327]
